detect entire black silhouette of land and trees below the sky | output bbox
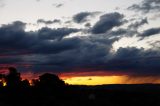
[0,67,160,106]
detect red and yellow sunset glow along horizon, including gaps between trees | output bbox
[1,70,160,86]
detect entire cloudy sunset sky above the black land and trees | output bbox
[0,0,160,85]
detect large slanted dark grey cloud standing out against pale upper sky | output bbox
[91,12,125,34]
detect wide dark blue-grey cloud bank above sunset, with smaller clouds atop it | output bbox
[0,9,160,75]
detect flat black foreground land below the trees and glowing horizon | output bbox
[0,84,160,106]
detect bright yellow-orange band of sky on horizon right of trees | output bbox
[62,75,160,85]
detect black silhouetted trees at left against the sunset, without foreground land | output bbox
[0,67,65,90]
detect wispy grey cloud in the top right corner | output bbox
[128,0,160,13]
